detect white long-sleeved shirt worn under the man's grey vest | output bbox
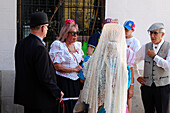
[134,39,170,78]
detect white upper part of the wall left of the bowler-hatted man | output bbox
[0,0,17,70]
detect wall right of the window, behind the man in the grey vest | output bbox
[105,0,170,113]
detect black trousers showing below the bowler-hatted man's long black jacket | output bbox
[24,107,58,113]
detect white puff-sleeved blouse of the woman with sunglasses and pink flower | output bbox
[49,40,84,80]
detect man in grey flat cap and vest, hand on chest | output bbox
[135,23,170,113]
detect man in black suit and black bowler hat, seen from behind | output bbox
[14,12,64,113]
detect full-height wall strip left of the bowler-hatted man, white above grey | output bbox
[0,0,19,113]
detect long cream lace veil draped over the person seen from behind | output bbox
[80,24,128,113]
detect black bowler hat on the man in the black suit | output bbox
[30,12,48,27]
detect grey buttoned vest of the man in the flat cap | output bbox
[144,41,170,86]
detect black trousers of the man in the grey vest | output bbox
[141,83,170,113]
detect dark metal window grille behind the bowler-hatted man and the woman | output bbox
[17,0,105,48]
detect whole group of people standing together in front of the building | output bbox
[14,12,170,113]
